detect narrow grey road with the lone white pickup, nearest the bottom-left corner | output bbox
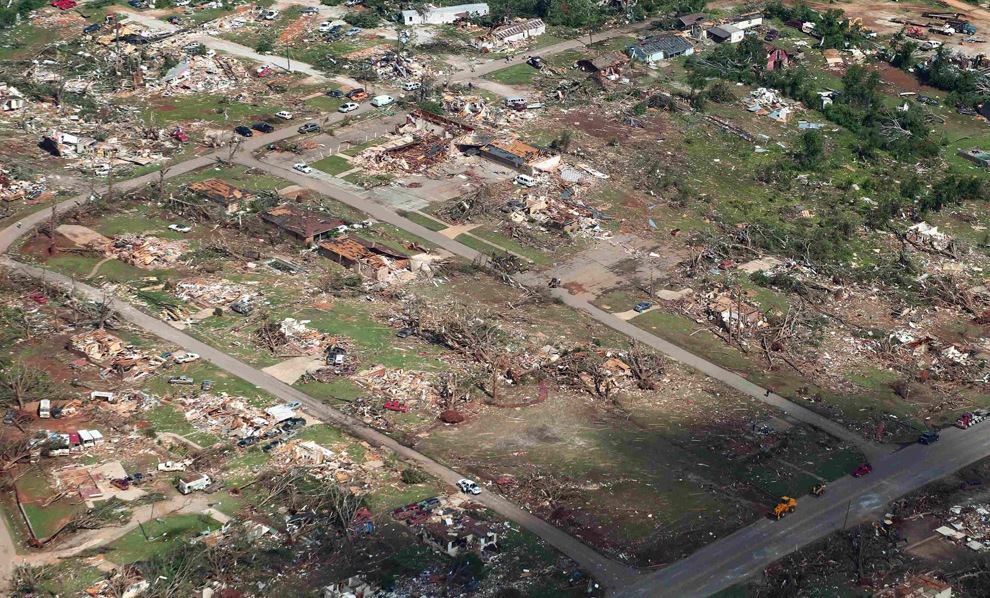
[2,260,636,588]
